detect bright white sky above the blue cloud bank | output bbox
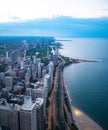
[0,0,108,23]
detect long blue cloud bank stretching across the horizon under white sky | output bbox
[0,16,108,37]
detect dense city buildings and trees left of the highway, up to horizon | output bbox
[0,37,58,130]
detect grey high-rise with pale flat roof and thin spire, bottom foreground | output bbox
[20,96,37,130]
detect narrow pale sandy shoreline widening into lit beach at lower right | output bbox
[63,59,104,130]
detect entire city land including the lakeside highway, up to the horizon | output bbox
[0,37,77,130]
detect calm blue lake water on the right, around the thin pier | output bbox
[60,38,108,130]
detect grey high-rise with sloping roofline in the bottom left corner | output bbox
[0,99,19,130]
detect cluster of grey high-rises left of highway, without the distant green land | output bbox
[0,38,58,130]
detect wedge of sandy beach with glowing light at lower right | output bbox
[72,106,103,130]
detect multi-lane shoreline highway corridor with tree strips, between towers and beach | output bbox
[45,56,78,130]
